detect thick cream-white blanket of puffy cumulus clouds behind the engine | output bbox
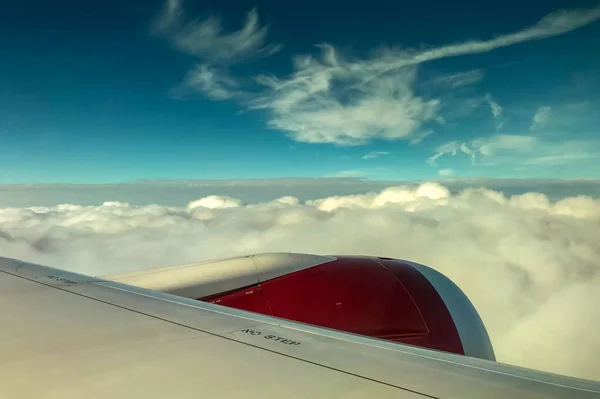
[0,183,600,380]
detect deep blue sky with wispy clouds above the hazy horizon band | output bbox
[0,0,600,183]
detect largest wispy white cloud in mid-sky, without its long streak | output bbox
[249,54,439,145]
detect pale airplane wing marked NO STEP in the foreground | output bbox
[0,258,600,399]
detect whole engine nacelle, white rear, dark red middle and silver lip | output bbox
[105,254,495,360]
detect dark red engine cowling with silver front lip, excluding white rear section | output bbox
[200,256,495,360]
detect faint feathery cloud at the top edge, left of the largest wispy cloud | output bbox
[154,0,280,62]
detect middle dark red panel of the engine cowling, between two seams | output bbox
[261,258,427,339]
